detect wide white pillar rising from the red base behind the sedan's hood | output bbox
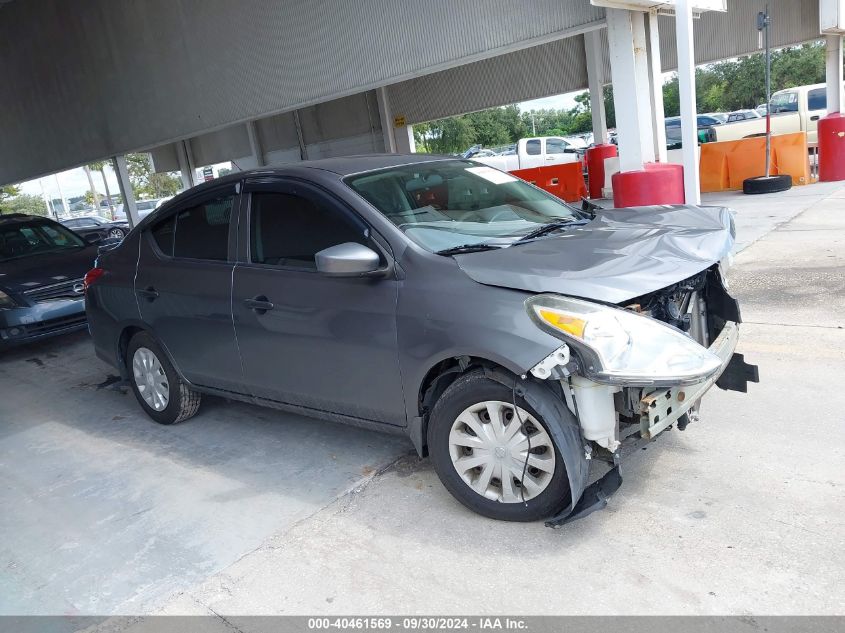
[606,9,654,172]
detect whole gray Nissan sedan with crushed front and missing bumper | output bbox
[86,155,757,525]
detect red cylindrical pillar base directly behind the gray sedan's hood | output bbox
[611,163,685,208]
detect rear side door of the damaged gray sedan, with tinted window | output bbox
[135,184,243,392]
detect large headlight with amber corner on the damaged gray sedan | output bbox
[525,295,722,386]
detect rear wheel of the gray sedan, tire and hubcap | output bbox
[126,332,201,424]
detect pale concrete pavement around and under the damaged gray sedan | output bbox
[0,185,845,632]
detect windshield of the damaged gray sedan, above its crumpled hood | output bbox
[345,160,580,253]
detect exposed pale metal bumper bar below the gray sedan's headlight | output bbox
[640,321,740,439]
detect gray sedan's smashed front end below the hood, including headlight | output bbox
[528,265,758,526]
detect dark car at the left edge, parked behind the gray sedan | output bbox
[0,214,97,348]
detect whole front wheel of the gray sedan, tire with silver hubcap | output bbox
[428,372,570,521]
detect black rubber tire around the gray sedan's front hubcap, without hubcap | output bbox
[428,371,571,521]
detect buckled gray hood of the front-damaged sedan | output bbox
[455,205,735,303]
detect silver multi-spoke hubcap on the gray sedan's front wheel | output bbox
[449,400,555,503]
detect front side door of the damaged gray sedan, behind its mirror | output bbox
[232,182,406,425]
